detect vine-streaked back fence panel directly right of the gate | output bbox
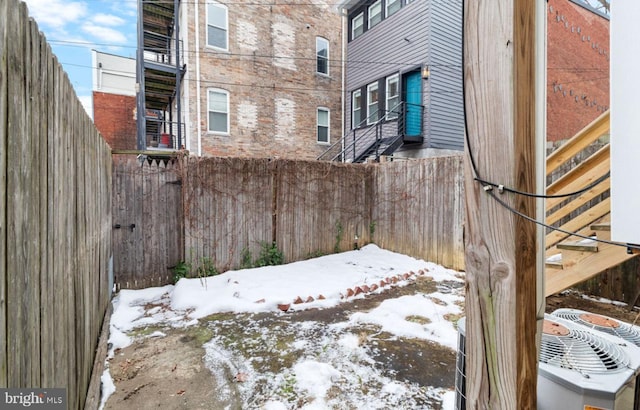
[183,158,275,271]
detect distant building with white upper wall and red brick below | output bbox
[92,50,136,149]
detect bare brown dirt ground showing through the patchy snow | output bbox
[105,280,638,410]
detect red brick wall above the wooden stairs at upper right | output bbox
[547,0,610,142]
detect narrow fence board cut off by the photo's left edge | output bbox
[0,1,9,386]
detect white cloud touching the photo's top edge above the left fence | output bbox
[26,0,87,29]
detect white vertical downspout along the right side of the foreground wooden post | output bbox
[535,0,547,350]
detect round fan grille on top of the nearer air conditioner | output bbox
[540,329,629,374]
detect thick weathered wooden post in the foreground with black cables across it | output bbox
[464,0,537,409]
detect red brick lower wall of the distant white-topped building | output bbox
[93,91,137,149]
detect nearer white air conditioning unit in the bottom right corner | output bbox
[538,315,640,410]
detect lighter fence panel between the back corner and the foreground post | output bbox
[372,156,464,270]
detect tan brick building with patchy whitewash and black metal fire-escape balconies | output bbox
[138,0,342,159]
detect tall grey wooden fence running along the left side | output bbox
[0,0,111,409]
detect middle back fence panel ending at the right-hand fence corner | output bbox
[273,161,373,261]
